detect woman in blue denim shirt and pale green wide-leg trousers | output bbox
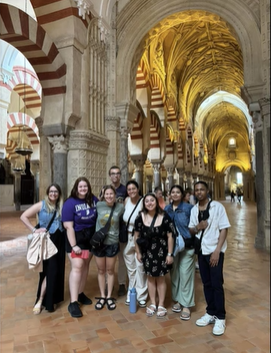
[165,185,195,320]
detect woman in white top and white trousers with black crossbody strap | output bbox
[123,180,148,308]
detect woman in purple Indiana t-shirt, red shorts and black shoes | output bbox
[62,177,98,317]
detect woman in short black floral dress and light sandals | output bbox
[134,193,174,318]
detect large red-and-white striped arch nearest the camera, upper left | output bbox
[0,4,66,96]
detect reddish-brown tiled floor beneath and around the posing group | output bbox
[0,201,270,353]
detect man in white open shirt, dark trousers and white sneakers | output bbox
[189,181,230,336]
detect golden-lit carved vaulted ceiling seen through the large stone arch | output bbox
[139,11,249,172]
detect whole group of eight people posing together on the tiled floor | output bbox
[21,166,230,335]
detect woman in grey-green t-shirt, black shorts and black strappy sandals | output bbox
[91,185,124,310]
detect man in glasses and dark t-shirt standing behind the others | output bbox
[99,166,127,297]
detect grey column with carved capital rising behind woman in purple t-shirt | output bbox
[48,135,67,199]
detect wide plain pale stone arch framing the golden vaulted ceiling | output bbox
[117,0,263,102]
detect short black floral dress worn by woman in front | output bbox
[134,213,174,277]
